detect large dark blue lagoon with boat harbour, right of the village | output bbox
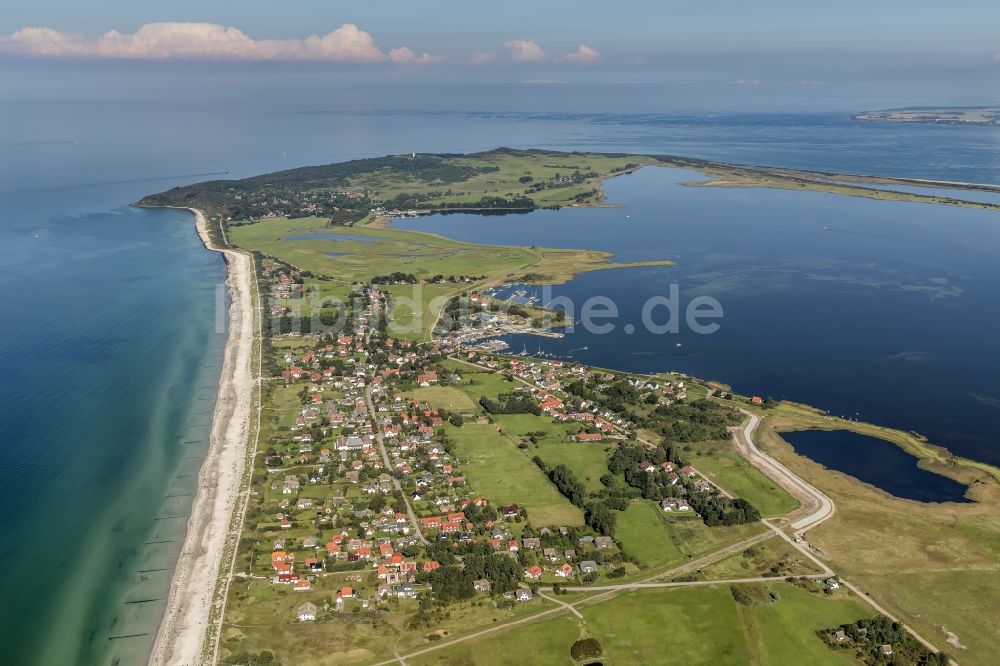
[395,168,1000,470]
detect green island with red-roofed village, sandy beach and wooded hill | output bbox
[138,149,1000,664]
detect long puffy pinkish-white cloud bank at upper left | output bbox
[0,23,438,63]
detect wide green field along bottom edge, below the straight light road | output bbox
[407,582,871,666]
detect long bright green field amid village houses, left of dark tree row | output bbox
[447,423,583,527]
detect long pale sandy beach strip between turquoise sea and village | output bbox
[149,209,254,665]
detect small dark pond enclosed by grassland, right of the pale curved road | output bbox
[781,430,967,502]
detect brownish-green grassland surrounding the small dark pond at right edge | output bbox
[758,405,1000,666]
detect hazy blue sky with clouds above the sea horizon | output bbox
[0,0,1000,110]
